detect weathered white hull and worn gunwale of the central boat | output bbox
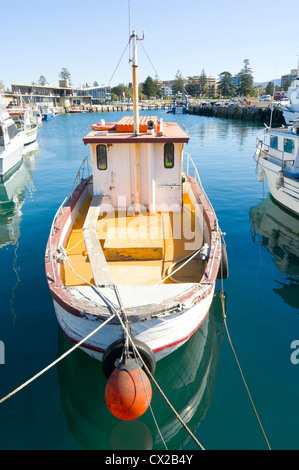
[45,169,221,361]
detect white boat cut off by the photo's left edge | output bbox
[0,96,25,180]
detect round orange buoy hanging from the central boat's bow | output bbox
[105,359,152,421]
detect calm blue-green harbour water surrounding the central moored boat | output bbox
[0,111,299,450]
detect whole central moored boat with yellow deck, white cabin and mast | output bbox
[45,32,228,377]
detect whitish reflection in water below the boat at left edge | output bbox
[0,143,39,248]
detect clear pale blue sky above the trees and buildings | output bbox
[0,0,299,87]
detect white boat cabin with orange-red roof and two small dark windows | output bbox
[83,117,189,213]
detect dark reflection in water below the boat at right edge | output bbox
[249,194,299,308]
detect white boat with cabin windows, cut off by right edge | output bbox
[254,119,299,215]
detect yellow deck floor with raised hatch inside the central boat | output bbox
[62,195,204,286]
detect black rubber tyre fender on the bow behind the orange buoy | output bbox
[102,338,156,379]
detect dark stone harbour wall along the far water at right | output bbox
[187,105,285,126]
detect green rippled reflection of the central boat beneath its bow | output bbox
[57,296,223,450]
